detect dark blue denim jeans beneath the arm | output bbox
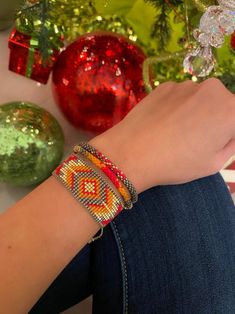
[30,174,235,314]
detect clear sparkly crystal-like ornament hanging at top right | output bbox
[184,0,235,77]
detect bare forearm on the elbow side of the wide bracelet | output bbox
[0,177,99,314]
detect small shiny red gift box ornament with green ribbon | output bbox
[8,29,60,84]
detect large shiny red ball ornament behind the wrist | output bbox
[53,32,146,132]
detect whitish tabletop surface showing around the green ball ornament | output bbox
[0,31,91,211]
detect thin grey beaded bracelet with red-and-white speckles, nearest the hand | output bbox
[74,142,138,203]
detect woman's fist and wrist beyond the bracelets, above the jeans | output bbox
[90,79,235,192]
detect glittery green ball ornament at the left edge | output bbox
[0,102,64,186]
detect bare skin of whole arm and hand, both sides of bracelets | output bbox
[0,80,235,314]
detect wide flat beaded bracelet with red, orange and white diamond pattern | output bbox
[53,154,123,227]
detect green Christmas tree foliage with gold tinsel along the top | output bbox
[6,0,235,91]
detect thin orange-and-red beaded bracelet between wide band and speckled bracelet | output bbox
[74,145,133,209]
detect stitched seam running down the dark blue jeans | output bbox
[110,221,128,314]
